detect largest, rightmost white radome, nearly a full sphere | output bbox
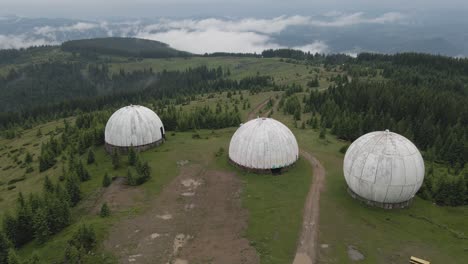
[343,130,424,204]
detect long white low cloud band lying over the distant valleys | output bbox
[0,11,404,54]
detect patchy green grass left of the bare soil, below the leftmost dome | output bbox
[0,92,282,263]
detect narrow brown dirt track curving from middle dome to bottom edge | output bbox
[293,150,325,264]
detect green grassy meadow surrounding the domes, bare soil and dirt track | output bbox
[0,58,468,264]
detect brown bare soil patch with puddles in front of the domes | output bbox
[104,165,259,264]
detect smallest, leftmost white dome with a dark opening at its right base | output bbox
[104,105,165,147]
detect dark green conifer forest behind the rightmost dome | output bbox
[268,51,468,205]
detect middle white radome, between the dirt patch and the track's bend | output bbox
[229,118,299,170]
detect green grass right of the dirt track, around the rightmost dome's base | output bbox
[288,122,468,264]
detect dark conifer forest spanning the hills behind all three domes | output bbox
[0,46,468,204]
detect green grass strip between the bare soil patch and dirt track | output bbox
[224,159,312,264]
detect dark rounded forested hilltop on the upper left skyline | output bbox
[62,37,191,58]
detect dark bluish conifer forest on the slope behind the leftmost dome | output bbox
[0,63,275,129]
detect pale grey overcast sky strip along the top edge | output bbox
[0,0,468,18]
